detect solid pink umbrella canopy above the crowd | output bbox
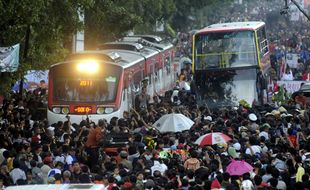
[226,160,253,176]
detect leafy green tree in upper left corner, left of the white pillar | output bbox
[0,0,88,94]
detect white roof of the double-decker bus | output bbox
[195,21,265,35]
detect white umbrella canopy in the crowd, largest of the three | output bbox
[153,113,194,133]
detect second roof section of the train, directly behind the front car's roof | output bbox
[99,41,158,58]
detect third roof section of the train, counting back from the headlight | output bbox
[120,36,173,51]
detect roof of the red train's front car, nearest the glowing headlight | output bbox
[51,49,145,68]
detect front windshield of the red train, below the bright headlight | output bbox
[51,64,121,103]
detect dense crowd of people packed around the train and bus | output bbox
[0,1,310,190]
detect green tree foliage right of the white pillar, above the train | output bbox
[85,0,175,49]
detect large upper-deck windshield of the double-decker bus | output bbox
[195,31,258,70]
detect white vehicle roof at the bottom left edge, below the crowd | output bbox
[5,184,105,190]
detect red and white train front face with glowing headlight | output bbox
[47,59,122,124]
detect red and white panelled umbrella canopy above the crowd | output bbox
[195,132,231,146]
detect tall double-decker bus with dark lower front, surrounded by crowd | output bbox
[192,21,270,107]
